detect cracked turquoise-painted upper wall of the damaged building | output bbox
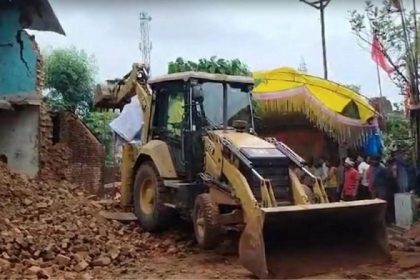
[0,7,38,98]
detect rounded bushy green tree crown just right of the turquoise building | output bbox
[44,47,96,116]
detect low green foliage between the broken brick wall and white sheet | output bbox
[84,111,117,164]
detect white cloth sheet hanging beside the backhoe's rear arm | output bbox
[109,96,144,142]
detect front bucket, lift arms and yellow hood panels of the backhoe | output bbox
[204,131,389,278]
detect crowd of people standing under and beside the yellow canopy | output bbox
[308,152,420,223]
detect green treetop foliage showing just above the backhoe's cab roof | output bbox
[168,56,251,76]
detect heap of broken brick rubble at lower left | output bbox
[0,163,191,279]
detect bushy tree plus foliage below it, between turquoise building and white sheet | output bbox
[44,47,116,163]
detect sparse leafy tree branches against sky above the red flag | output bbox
[350,0,418,88]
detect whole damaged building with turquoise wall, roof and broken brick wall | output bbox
[0,0,104,190]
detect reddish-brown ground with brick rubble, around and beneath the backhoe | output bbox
[0,162,420,279]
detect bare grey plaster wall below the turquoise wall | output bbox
[0,106,39,176]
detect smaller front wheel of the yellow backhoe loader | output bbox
[193,193,222,250]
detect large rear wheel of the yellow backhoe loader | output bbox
[133,162,173,232]
